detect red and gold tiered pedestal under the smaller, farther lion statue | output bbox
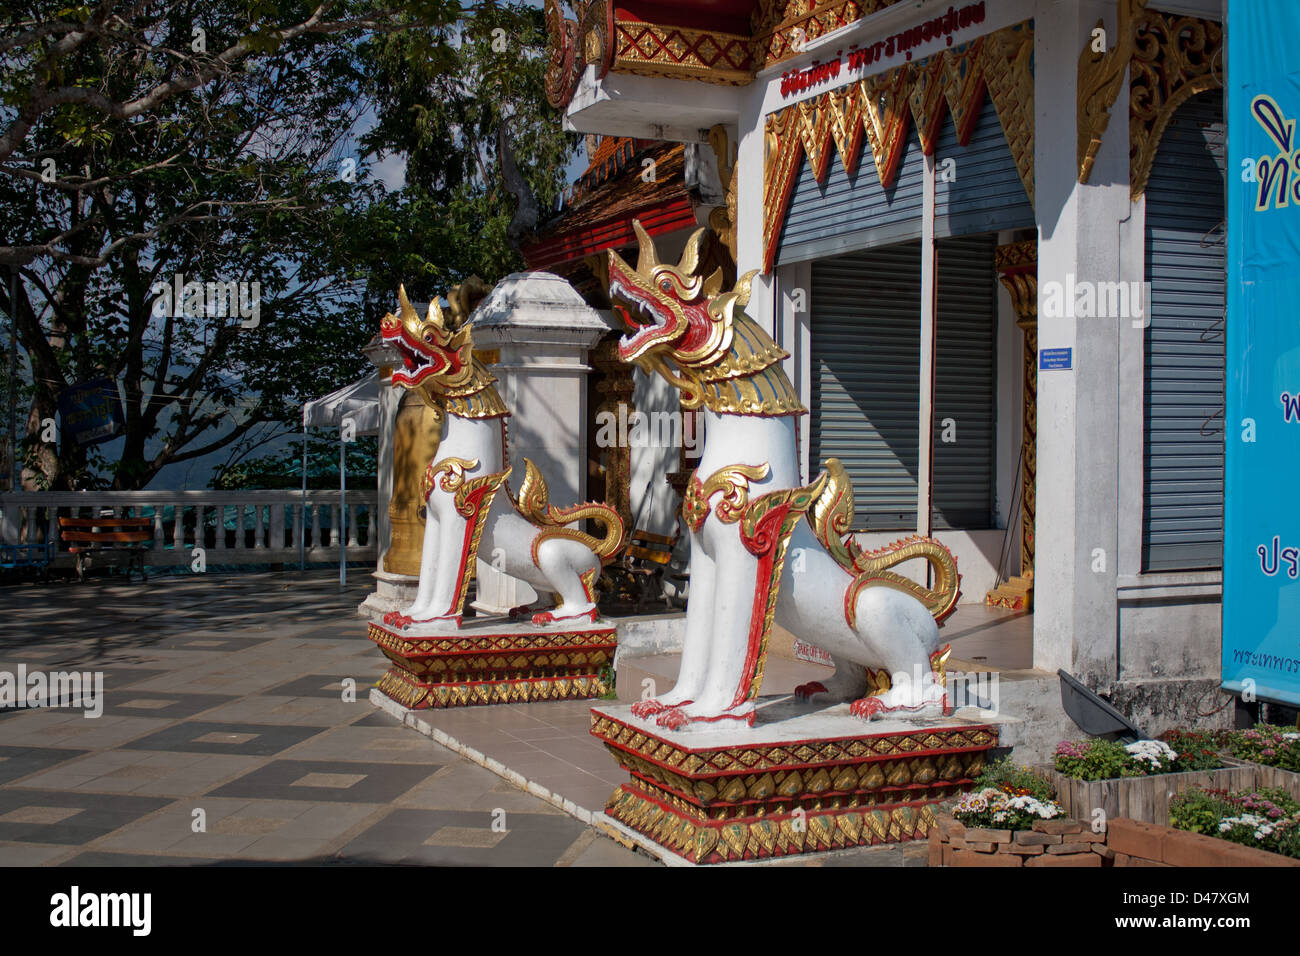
[367,620,618,710]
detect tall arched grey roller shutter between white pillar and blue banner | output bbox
[1143,91,1226,571]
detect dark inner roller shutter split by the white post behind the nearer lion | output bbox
[810,237,996,531]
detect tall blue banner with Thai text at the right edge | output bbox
[1223,0,1300,704]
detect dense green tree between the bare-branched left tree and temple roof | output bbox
[363,3,579,300]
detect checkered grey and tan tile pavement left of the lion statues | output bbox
[0,571,658,866]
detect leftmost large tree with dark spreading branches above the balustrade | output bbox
[0,0,460,488]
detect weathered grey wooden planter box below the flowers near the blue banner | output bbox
[1044,761,1258,826]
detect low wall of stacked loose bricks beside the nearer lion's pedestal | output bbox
[930,813,1114,866]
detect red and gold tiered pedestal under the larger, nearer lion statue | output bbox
[592,705,997,864]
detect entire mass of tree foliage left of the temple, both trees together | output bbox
[0,0,573,488]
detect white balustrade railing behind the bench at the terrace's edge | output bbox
[0,490,378,566]
